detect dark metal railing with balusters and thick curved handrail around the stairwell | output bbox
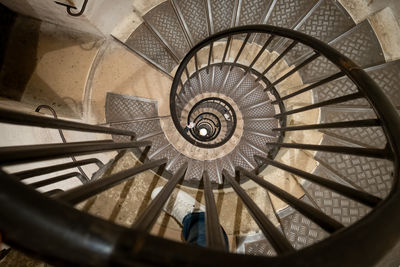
[0,25,400,266]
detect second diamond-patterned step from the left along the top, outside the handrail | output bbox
[143,1,190,59]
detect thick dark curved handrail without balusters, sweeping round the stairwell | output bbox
[0,25,400,266]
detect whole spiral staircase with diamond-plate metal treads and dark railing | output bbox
[0,0,400,266]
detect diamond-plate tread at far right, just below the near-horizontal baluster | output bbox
[315,136,393,198]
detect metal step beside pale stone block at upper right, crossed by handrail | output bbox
[299,20,385,83]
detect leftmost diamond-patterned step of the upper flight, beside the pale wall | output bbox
[125,24,177,73]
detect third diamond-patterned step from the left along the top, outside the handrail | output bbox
[172,0,209,46]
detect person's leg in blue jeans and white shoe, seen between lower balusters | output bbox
[151,187,229,250]
